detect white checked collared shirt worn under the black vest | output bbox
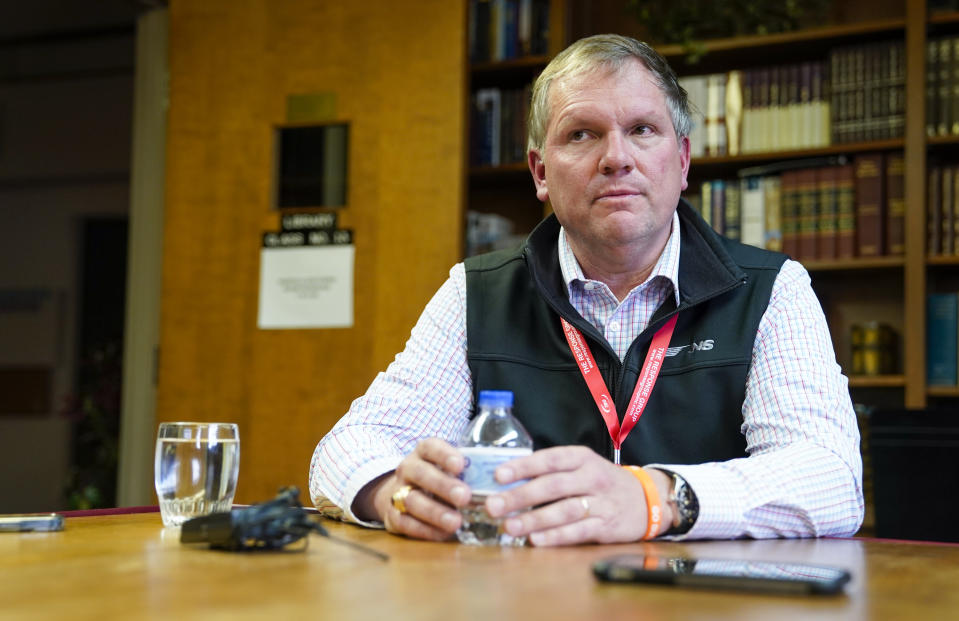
[310,216,863,538]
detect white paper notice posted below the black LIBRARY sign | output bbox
[257,244,355,330]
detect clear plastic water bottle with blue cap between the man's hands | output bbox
[456,390,533,546]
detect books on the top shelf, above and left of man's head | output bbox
[469,0,549,62]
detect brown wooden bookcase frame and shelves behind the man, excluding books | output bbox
[465,0,959,408]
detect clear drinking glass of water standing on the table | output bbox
[153,423,240,526]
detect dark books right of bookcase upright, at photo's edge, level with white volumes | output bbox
[926,35,959,136]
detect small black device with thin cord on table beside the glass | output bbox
[180,486,389,560]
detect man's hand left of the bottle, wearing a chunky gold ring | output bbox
[353,438,470,541]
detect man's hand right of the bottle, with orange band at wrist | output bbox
[486,446,673,546]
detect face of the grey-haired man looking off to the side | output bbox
[529,60,689,252]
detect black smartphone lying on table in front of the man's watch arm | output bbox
[593,554,850,595]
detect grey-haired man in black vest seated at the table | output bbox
[310,35,863,545]
